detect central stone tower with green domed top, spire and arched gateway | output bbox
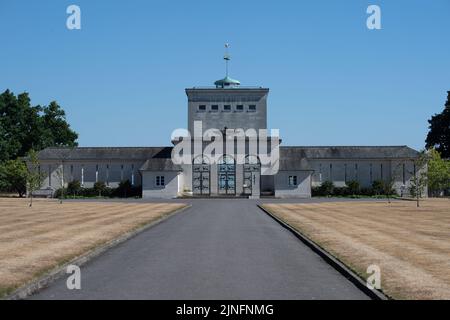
[179,45,269,197]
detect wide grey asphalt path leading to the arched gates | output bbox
[31,199,368,299]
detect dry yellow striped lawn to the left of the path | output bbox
[0,199,184,297]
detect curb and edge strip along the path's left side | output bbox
[5,204,192,300]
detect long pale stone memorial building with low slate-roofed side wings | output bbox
[33,81,426,198]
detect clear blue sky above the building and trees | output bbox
[0,0,450,149]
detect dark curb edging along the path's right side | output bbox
[257,204,390,300]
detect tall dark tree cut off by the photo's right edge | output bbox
[426,91,450,158]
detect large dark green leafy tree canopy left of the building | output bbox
[0,90,78,161]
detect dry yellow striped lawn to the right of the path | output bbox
[264,199,450,299]
